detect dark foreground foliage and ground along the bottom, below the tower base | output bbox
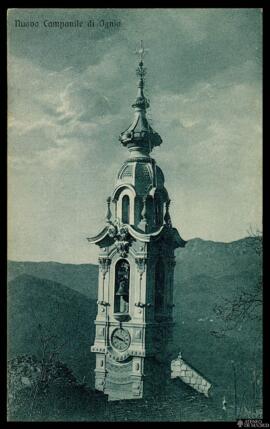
[8,355,261,421]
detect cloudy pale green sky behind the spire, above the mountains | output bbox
[8,8,262,263]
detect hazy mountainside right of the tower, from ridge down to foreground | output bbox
[174,237,262,398]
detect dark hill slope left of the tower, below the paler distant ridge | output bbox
[7,274,96,385]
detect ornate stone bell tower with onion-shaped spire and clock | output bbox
[88,43,185,400]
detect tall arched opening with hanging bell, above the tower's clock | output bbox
[114,259,130,314]
